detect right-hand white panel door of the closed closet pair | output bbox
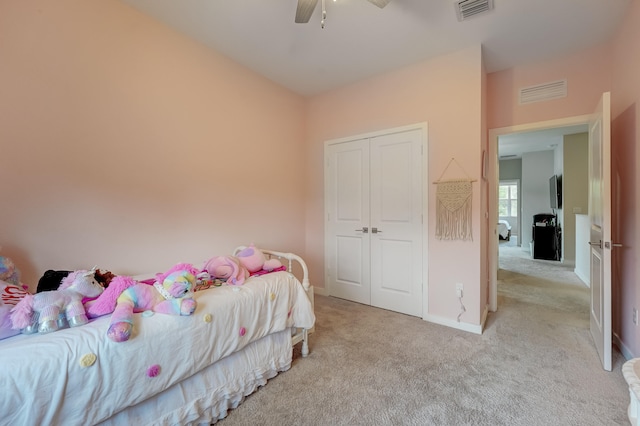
[370,130,423,317]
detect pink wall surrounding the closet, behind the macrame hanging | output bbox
[306,46,484,324]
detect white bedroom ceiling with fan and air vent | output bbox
[122,0,632,96]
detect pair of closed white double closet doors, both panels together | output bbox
[325,130,423,317]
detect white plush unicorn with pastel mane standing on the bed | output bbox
[11,269,104,334]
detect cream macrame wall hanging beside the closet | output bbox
[433,158,476,241]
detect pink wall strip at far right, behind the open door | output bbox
[611,1,640,356]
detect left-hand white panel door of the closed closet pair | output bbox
[325,139,371,305]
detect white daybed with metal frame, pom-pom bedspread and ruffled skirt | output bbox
[0,250,315,425]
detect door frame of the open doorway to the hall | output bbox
[487,114,591,312]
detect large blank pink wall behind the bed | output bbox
[0,0,304,289]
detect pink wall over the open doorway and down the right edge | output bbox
[488,2,640,356]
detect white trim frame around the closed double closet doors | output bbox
[323,121,431,319]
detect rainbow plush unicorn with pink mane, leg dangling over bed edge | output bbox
[88,263,199,342]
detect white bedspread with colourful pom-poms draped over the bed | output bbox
[0,272,315,425]
